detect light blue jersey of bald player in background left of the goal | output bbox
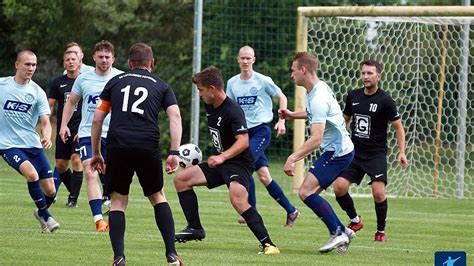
[226,71,281,128]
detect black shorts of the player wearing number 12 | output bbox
[105,149,163,197]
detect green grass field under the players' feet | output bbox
[0,155,474,265]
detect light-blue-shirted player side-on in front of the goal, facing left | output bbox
[279,52,355,253]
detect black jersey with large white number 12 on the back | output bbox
[100,68,177,150]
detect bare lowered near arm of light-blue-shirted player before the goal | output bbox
[283,123,326,176]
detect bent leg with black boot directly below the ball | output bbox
[174,163,207,242]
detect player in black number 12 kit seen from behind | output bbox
[91,43,183,265]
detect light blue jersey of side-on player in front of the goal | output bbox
[306,80,354,157]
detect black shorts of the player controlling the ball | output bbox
[199,161,253,191]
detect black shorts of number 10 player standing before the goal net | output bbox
[340,152,387,185]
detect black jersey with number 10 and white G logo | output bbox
[344,88,400,153]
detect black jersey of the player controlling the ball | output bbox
[205,97,253,164]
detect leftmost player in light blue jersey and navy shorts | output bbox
[0,50,59,233]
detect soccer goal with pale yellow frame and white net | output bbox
[293,6,474,198]
